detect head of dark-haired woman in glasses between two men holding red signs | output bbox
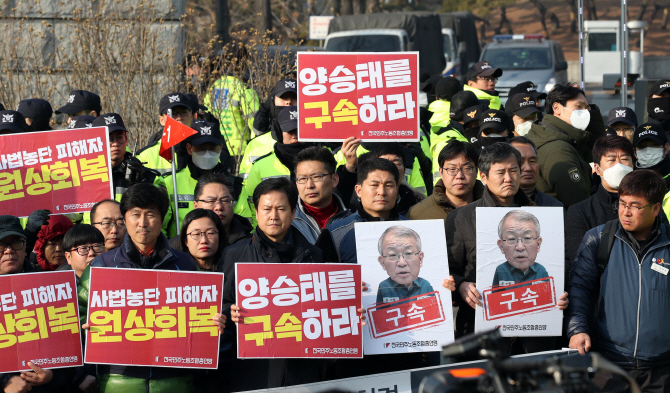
[179,209,226,271]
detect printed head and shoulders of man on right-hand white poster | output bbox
[493,210,549,286]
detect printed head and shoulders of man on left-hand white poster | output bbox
[377,225,433,303]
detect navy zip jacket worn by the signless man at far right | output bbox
[567,219,670,367]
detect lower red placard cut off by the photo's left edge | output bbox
[0,271,83,373]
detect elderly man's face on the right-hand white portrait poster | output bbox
[498,216,542,271]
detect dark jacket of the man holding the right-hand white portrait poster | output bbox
[444,188,535,337]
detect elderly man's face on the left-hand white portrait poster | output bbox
[379,232,423,287]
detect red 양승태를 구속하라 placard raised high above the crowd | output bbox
[297,52,419,142]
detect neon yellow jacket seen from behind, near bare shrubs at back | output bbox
[203,75,260,156]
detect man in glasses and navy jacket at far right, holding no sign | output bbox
[566,170,670,392]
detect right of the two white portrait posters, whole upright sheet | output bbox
[475,207,565,337]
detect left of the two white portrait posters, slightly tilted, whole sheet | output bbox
[354,220,454,355]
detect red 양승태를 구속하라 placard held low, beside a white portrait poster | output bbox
[235,263,363,358]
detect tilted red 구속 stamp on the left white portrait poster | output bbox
[366,291,445,338]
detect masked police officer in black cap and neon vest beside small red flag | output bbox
[163,120,226,238]
